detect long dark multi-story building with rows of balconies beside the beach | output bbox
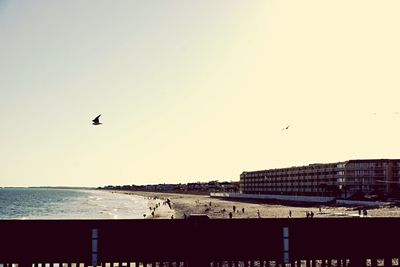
[240,159,400,198]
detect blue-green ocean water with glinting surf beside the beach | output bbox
[0,188,149,220]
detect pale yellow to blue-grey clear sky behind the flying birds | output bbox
[0,0,400,186]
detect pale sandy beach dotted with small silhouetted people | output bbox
[109,191,400,219]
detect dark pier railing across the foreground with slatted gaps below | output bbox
[0,216,400,267]
